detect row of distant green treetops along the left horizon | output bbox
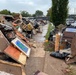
[0,9,43,17]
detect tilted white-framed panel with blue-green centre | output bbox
[11,38,31,57]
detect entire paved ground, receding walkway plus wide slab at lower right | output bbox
[25,25,67,75]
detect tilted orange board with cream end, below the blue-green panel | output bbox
[4,45,27,65]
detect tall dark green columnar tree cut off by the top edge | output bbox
[51,0,69,26]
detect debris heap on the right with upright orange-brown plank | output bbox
[48,24,76,64]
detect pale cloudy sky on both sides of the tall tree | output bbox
[0,0,76,14]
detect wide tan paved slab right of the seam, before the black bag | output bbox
[43,51,68,75]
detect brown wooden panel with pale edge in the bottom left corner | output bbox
[0,60,26,75]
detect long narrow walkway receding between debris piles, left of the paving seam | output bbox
[25,24,48,75]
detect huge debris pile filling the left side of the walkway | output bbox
[0,14,47,75]
